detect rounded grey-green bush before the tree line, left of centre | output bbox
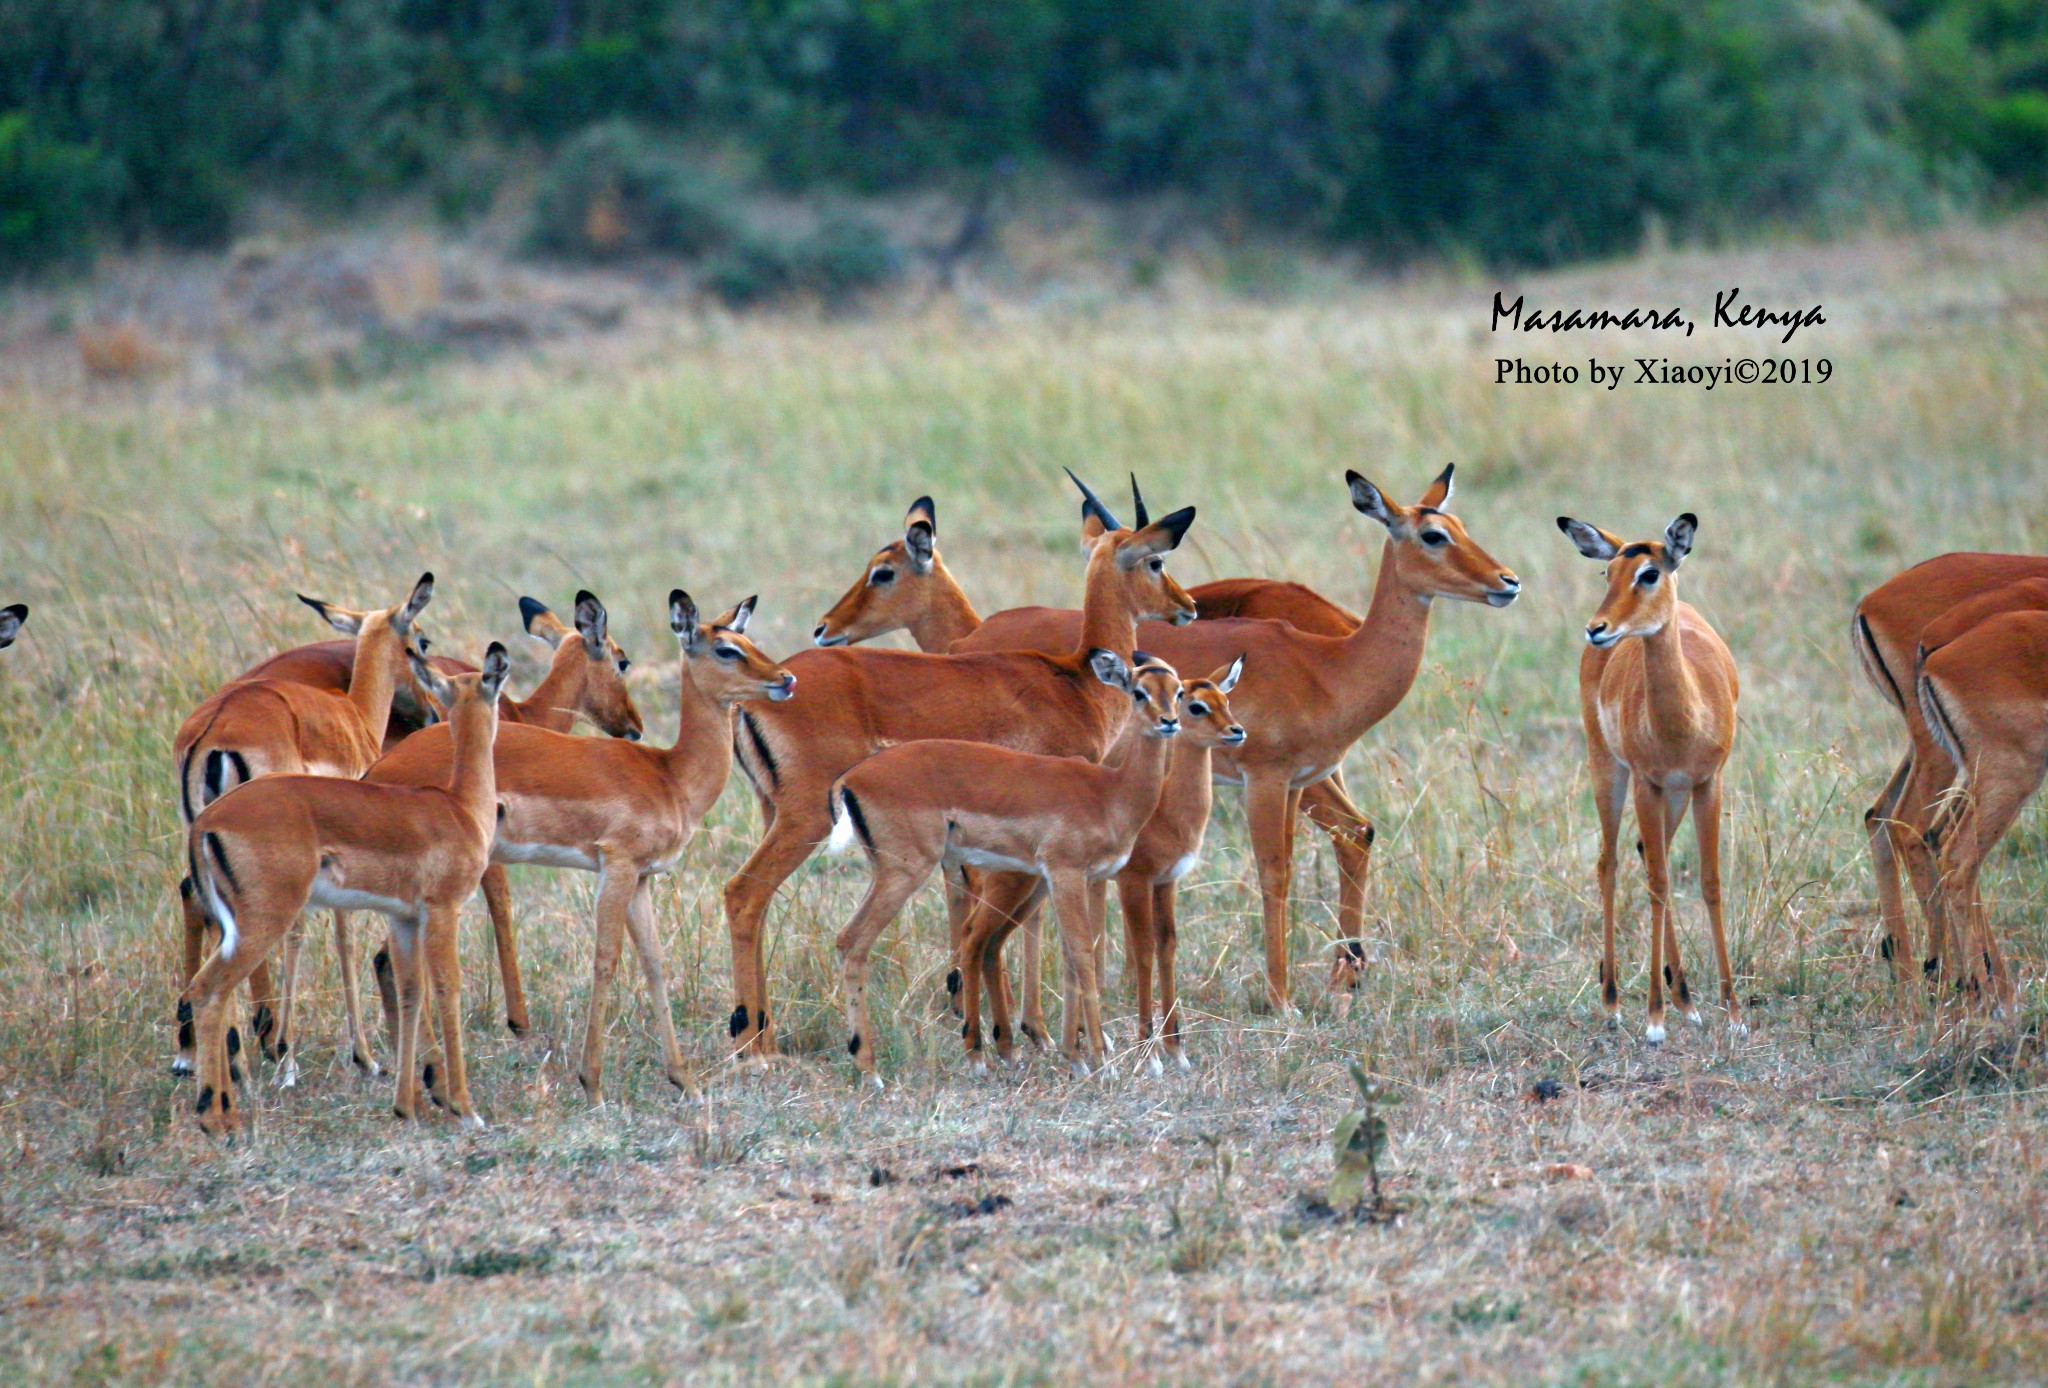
[526,121,739,260]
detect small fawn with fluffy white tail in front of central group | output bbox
[831,649,1182,1087]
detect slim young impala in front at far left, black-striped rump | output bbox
[178,641,512,1134]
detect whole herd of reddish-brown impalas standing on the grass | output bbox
[0,467,2015,1134]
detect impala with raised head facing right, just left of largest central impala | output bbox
[371,588,790,1099]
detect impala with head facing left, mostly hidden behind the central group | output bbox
[811,495,1372,1038]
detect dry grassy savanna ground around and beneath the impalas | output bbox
[0,225,2048,1384]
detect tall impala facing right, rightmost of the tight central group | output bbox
[956,467,1522,1009]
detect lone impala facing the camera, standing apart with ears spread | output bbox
[1556,512,1743,1046]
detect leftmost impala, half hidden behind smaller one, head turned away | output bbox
[172,573,434,1085]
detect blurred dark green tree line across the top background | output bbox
[0,0,2048,266]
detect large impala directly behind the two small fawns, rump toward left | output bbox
[725,479,1194,1050]
